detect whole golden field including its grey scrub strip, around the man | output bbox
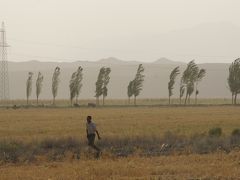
[0,106,240,179]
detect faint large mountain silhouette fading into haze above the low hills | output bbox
[68,22,240,62]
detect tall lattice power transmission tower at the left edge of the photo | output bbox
[0,22,10,100]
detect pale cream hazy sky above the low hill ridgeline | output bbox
[0,0,240,62]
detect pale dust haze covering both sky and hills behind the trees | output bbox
[0,0,240,99]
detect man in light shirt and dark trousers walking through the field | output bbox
[86,116,101,158]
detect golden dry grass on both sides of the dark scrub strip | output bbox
[0,106,240,179]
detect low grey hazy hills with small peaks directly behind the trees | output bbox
[9,57,231,99]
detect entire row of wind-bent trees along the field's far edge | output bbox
[26,58,240,105]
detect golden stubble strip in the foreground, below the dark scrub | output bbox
[0,153,240,180]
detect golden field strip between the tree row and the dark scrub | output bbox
[0,106,240,141]
